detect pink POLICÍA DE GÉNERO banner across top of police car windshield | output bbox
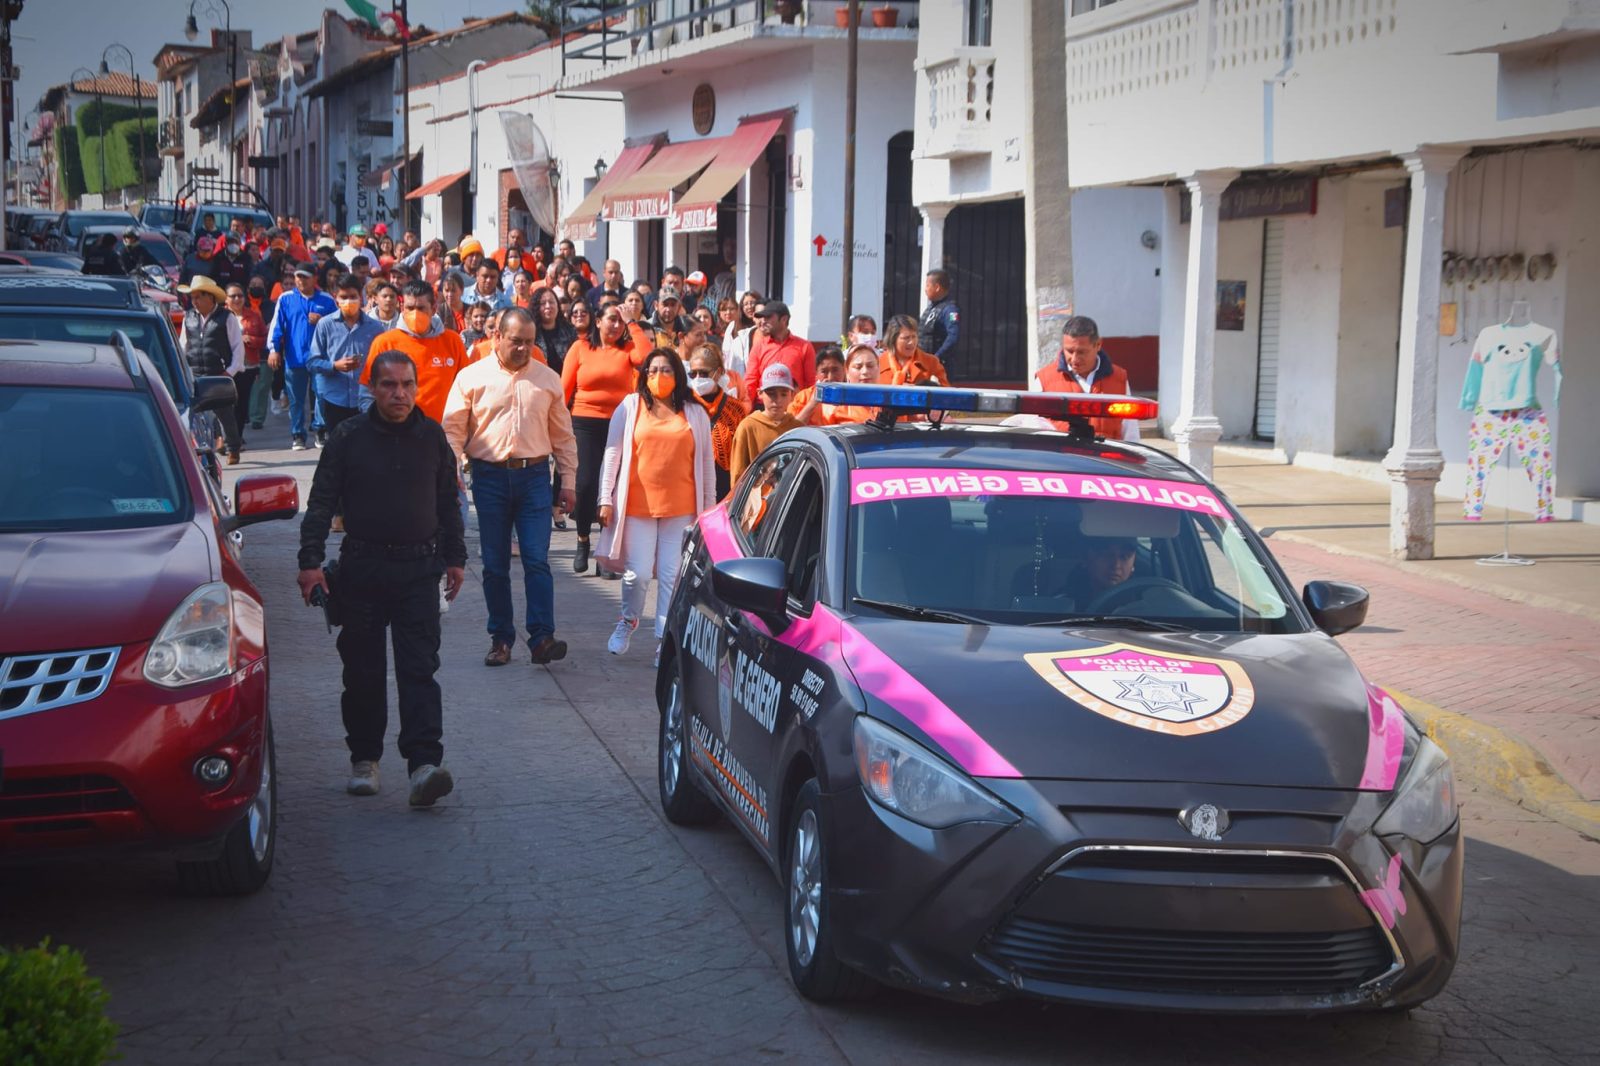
[850,466,1227,519]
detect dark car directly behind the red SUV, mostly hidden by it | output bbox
[0,267,222,483]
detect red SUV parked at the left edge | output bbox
[0,333,299,893]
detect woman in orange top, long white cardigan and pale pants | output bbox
[597,347,717,663]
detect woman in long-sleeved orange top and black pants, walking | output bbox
[562,307,648,573]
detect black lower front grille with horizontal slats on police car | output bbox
[986,917,1394,996]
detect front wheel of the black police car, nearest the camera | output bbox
[782,778,877,1004]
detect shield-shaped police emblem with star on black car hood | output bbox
[1027,643,1256,736]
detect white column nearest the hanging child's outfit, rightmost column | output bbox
[1384,147,1462,559]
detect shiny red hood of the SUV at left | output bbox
[0,522,214,655]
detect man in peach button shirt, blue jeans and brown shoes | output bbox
[443,307,578,666]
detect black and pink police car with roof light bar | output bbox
[656,384,1462,1013]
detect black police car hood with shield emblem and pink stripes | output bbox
[845,616,1390,789]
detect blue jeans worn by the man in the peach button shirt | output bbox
[472,459,555,647]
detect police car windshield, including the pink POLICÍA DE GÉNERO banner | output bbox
[850,469,1302,632]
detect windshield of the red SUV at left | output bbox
[0,386,189,533]
